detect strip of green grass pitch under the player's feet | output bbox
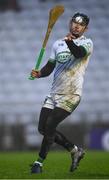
[0,151,109,179]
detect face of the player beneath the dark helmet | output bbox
[70,22,87,37]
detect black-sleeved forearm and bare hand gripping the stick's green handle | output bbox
[31,60,56,78]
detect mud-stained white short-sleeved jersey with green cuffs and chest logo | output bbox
[49,36,93,96]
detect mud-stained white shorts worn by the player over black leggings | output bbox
[43,94,81,113]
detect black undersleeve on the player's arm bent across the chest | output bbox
[65,40,87,58]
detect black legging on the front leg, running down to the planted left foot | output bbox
[39,107,70,159]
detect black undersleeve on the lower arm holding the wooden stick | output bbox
[40,61,56,77]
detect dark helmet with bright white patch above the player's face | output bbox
[72,13,90,26]
